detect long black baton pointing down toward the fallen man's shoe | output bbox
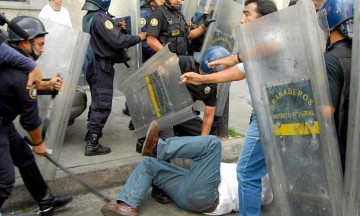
[24,136,111,203]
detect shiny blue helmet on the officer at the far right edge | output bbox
[318,0,354,37]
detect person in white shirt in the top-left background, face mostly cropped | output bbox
[39,0,72,27]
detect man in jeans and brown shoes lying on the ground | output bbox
[101,121,273,216]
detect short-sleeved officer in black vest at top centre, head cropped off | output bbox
[146,0,206,55]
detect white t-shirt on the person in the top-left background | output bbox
[39,4,72,27]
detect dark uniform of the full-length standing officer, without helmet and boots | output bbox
[85,10,141,134]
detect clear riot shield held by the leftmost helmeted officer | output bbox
[36,19,90,179]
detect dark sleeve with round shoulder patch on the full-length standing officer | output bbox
[92,15,141,49]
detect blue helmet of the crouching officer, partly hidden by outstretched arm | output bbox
[194,46,230,74]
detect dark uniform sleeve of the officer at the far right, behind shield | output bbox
[324,53,344,107]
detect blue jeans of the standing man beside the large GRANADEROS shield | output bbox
[237,113,267,216]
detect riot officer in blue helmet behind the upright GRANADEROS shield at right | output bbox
[319,0,354,174]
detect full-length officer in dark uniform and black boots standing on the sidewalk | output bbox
[82,0,146,156]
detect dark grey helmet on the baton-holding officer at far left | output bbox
[7,16,48,42]
